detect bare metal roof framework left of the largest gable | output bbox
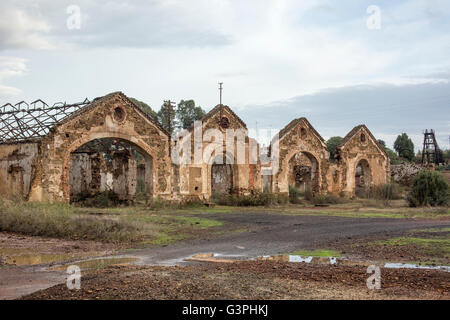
[0,98,91,143]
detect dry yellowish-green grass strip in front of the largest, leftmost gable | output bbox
[0,201,232,244]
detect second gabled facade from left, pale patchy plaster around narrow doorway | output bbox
[177,107,262,200]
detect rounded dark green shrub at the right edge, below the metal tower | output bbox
[408,170,450,207]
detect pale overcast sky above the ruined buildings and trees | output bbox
[0,0,450,149]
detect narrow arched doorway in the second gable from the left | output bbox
[211,156,233,196]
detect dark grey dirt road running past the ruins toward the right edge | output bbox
[127,212,450,265]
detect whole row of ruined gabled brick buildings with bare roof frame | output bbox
[0,92,390,202]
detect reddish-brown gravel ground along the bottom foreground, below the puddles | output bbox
[23,261,450,300]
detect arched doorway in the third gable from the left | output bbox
[288,152,319,192]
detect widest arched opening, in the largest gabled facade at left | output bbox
[69,138,153,203]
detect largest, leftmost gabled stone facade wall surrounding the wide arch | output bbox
[27,93,173,202]
